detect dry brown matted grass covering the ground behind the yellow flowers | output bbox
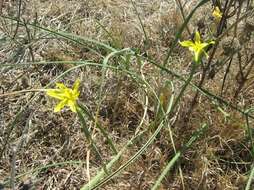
[0,0,254,190]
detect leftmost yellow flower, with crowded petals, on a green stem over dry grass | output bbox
[46,80,80,112]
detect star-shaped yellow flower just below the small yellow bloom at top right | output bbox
[179,32,215,63]
